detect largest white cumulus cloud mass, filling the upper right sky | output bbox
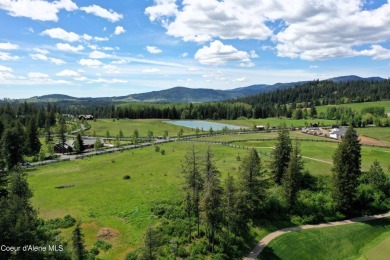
[145,0,390,61]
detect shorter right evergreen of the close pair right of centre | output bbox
[282,141,303,209]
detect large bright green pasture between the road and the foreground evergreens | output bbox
[28,142,246,259]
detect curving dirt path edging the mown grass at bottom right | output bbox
[244,212,390,260]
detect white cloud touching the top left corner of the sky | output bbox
[0,0,78,21]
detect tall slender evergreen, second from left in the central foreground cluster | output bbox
[200,147,222,253]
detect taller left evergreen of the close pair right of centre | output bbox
[271,124,292,184]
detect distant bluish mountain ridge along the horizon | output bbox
[30,75,385,103]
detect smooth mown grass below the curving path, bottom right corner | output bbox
[259,218,390,260]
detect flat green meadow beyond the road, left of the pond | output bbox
[85,119,195,137]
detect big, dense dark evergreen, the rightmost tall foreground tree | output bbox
[332,127,361,214]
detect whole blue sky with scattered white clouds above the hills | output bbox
[0,0,390,98]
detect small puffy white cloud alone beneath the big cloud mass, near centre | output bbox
[195,41,250,65]
